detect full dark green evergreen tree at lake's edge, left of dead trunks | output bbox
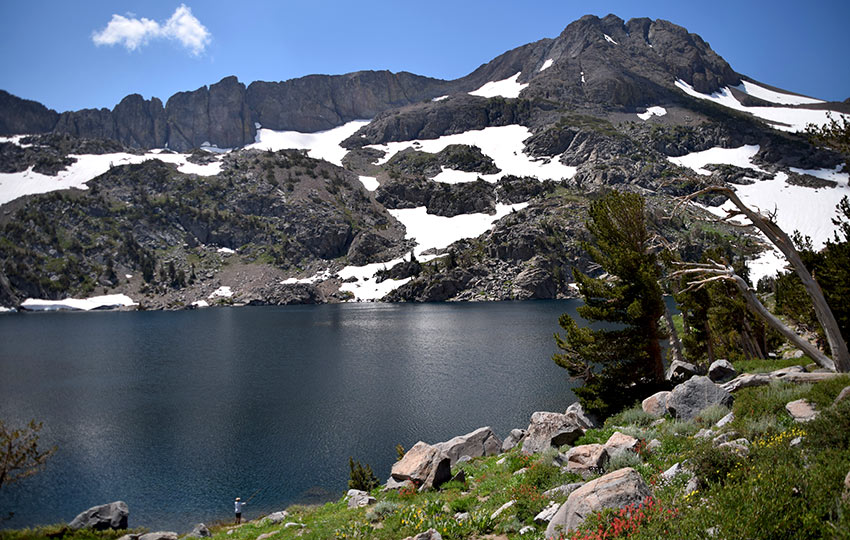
[553,191,665,417]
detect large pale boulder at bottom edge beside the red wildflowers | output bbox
[546,467,652,538]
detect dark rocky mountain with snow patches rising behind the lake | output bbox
[0,15,848,308]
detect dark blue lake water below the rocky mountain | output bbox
[0,301,578,532]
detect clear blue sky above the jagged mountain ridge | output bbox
[0,0,850,112]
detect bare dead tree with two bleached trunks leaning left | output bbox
[679,185,850,372]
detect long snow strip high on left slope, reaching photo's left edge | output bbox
[0,150,221,204]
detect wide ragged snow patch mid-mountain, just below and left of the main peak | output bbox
[368,125,577,183]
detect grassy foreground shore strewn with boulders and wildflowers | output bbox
[48,354,850,540]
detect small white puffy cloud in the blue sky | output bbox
[92,4,212,55]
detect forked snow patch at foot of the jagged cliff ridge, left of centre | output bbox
[246,120,369,167]
